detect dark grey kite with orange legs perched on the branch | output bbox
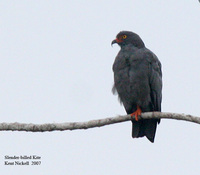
[111,31,162,143]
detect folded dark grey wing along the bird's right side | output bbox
[148,51,162,111]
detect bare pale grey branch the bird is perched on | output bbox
[0,112,200,132]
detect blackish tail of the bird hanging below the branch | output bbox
[132,119,160,143]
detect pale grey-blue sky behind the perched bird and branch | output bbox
[0,0,200,175]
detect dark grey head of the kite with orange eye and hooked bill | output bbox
[111,31,145,48]
